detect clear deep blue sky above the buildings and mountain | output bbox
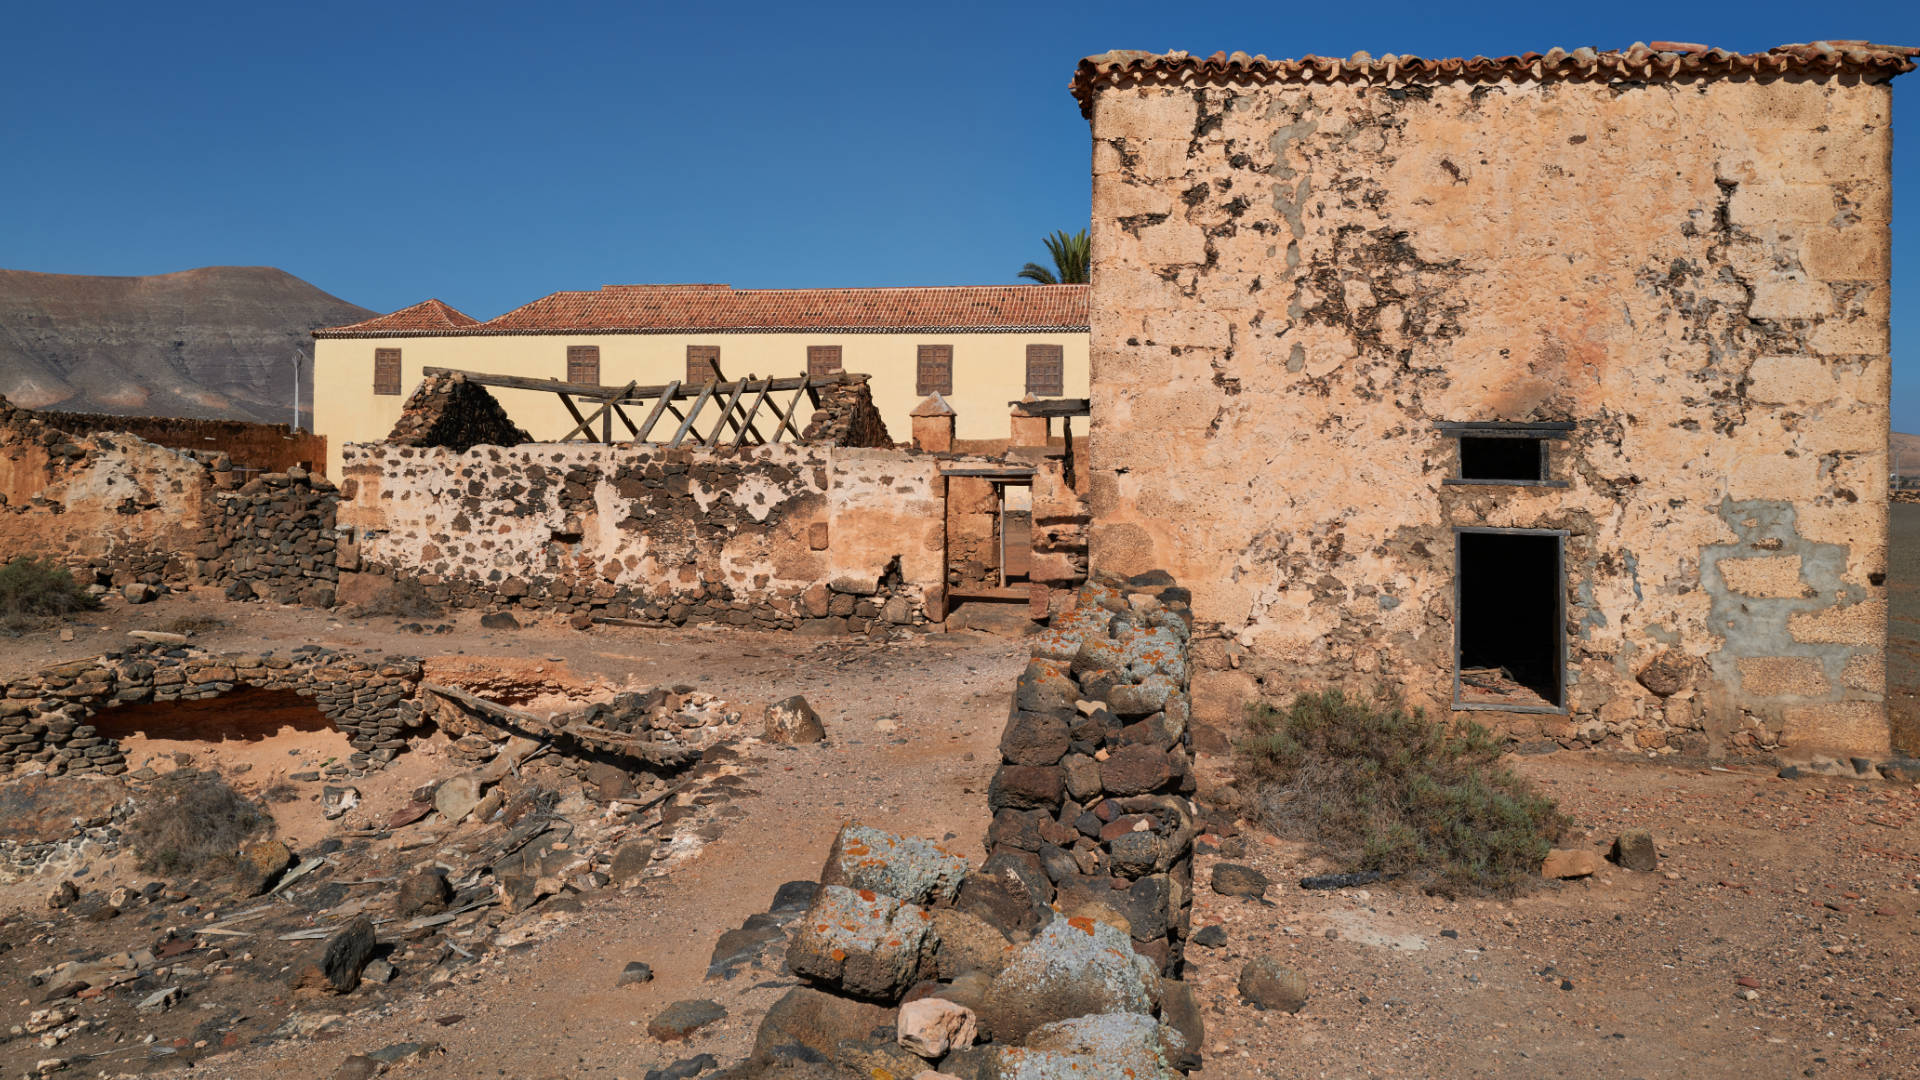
[0,0,1920,422]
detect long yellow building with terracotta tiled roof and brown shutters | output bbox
[313,284,1089,477]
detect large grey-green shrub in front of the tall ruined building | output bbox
[1235,690,1567,896]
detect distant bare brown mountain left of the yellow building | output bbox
[0,267,372,425]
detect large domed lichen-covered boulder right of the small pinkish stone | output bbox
[981,917,1160,1043]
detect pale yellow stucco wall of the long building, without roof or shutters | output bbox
[313,332,1087,477]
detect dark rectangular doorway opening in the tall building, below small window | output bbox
[1453,528,1567,711]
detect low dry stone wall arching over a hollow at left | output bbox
[0,644,424,774]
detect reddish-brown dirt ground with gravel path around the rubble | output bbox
[0,588,1920,1080]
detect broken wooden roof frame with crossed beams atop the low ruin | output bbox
[422,363,845,450]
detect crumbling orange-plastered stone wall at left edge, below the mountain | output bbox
[0,400,338,607]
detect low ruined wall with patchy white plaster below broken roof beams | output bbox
[340,444,945,632]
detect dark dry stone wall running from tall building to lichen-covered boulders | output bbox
[983,573,1200,974]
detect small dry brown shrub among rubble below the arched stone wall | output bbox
[127,773,273,876]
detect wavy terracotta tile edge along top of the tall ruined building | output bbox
[1069,40,1920,113]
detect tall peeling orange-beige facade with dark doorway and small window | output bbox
[1091,77,1891,757]
